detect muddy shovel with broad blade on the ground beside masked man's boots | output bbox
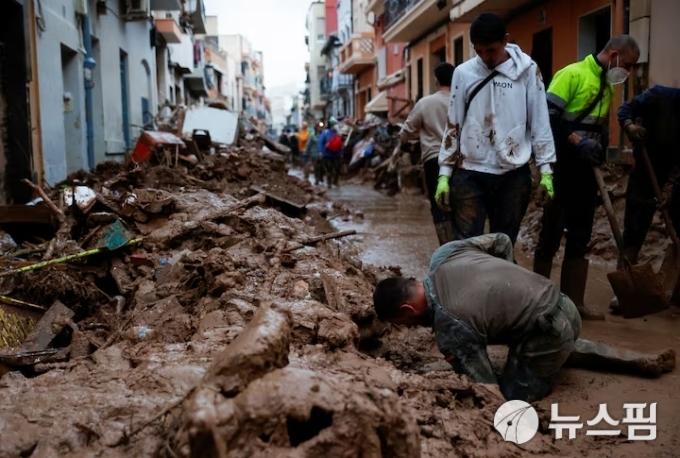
[593,167,668,318]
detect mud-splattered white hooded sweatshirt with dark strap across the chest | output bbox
[439,44,555,176]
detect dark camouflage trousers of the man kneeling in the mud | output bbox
[499,294,581,402]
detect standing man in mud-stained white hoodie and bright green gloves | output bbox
[435,13,555,244]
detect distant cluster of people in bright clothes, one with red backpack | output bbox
[279,117,344,189]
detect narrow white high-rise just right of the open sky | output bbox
[305,1,328,120]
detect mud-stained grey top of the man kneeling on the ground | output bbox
[424,234,559,383]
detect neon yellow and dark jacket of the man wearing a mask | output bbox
[547,54,613,146]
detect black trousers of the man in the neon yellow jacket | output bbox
[535,148,598,260]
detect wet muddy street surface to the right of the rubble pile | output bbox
[328,179,680,458]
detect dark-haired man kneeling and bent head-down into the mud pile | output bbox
[373,234,581,402]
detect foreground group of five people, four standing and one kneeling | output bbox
[373,13,680,401]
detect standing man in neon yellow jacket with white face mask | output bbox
[534,35,640,320]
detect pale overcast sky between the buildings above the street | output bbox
[205,0,312,90]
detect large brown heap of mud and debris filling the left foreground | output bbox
[0,121,550,457]
